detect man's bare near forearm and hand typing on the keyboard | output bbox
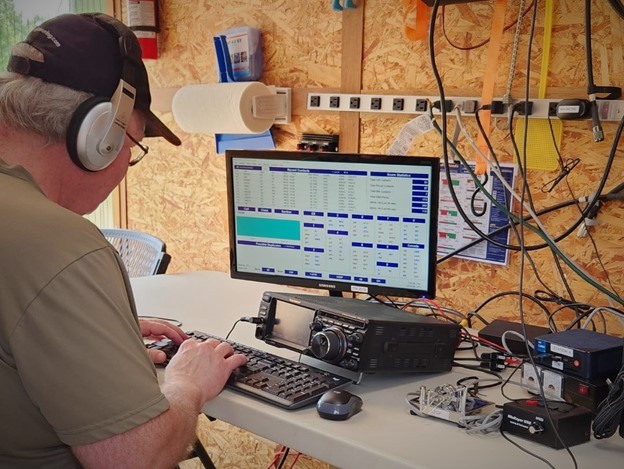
[72,339,247,468]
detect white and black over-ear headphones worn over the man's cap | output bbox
[66,14,136,171]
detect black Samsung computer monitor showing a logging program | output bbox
[225,150,440,298]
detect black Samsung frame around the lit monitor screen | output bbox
[225,150,440,299]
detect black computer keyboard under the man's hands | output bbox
[146,331,351,409]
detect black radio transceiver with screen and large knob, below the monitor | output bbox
[256,292,460,372]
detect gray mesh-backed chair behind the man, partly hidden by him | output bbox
[101,228,216,469]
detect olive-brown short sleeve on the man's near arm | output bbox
[11,248,168,446]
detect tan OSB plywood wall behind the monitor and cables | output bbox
[128,0,624,332]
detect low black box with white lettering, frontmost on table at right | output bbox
[501,399,592,449]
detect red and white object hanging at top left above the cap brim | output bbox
[126,0,160,59]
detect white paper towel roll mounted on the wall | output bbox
[171,81,274,134]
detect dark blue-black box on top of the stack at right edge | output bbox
[535,329,624,379]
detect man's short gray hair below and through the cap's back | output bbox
[0,43,92,142]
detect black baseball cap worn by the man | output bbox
[7,13,181,145]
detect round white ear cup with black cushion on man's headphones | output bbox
[66,96,118,171]
